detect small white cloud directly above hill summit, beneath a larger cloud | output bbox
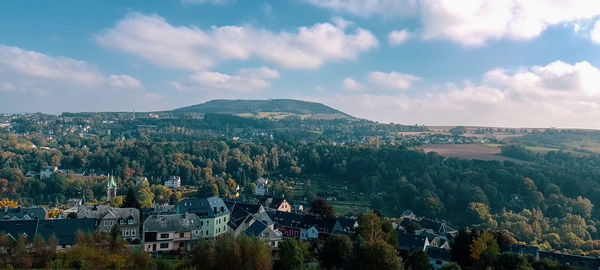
[172,67,279,92]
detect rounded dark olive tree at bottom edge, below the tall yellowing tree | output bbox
[352,240,404,270]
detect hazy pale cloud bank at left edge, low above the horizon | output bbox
[0,45,165,113]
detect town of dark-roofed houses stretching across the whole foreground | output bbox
[0,166,600,270]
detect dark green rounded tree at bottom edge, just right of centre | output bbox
[319,234,352,269]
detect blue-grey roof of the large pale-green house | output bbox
[176,197,230,218]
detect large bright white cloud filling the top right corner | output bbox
[421,0,600,46]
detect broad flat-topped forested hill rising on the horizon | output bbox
[170,99,354,118]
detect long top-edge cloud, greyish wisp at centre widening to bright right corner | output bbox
[307,0,600,46]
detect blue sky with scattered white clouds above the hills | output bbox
[0,0,600,129]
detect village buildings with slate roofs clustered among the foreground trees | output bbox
[0,166,600,270]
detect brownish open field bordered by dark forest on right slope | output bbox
[421,144,523,162]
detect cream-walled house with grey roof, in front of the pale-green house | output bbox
[142,214,202,252]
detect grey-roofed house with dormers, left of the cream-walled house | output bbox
[77,205,141,243]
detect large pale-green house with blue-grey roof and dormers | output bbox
[176,197,230,238]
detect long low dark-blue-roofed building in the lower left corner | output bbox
[0,218,96,250]
